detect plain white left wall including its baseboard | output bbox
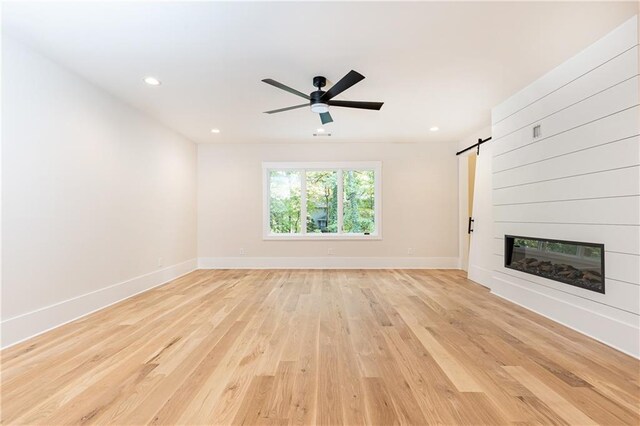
[2,37,197,346]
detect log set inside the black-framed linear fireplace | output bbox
[510,257,602,291]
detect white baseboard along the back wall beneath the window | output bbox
[198,256,460,269]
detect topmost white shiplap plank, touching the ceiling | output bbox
[491,16,638,124]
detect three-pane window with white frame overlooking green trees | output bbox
[262,162,382,239]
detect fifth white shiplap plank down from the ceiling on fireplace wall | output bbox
[493,136,640,189]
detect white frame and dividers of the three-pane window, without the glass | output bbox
[262,161,382,240]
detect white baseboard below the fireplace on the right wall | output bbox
[491,276,640,358]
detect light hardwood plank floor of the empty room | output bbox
[1,270,640,425]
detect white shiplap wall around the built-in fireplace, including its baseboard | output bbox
[491,16,640,357]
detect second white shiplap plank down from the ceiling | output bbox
[492,46,638,139]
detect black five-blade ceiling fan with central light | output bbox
[262,70,384,124]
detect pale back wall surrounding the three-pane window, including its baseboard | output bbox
[198,141,458,267]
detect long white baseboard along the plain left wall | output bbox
[0,259,197,348]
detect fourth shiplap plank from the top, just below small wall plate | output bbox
[493,106,640,173]
